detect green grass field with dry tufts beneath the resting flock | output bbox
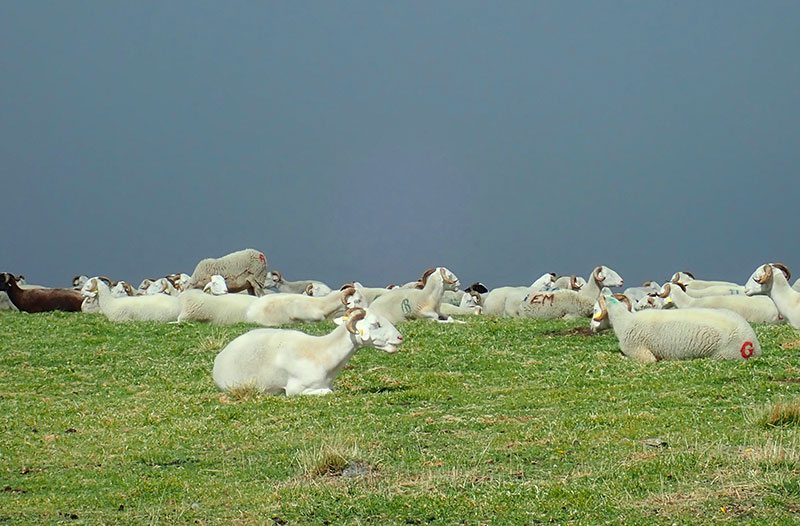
[0,313,800,525]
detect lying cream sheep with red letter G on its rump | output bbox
[591,295,761,363]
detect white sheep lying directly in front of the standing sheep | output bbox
[178,289,258,325]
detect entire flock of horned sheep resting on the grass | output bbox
[0,249,800,395]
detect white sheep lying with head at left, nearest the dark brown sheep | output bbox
[82,277,181,322]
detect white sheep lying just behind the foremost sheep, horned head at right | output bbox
[245,287,365,327]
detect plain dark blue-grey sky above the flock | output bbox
[0,0,800,286]
